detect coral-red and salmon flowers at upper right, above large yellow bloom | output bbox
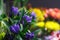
[45,8,60,20]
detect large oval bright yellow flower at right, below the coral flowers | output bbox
[45,21,59,30]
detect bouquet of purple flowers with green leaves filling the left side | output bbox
[0,0,37,40]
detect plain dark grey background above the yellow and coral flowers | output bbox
[28,0,60,8]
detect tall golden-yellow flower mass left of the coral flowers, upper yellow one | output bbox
[33,8,45,21]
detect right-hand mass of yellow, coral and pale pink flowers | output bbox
[29,8,60,40]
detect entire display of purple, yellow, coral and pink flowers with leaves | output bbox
[0,0,60,40]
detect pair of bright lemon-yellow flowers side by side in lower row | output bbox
[36,21,60,30]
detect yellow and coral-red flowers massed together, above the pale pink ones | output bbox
[33,8,60,30]
